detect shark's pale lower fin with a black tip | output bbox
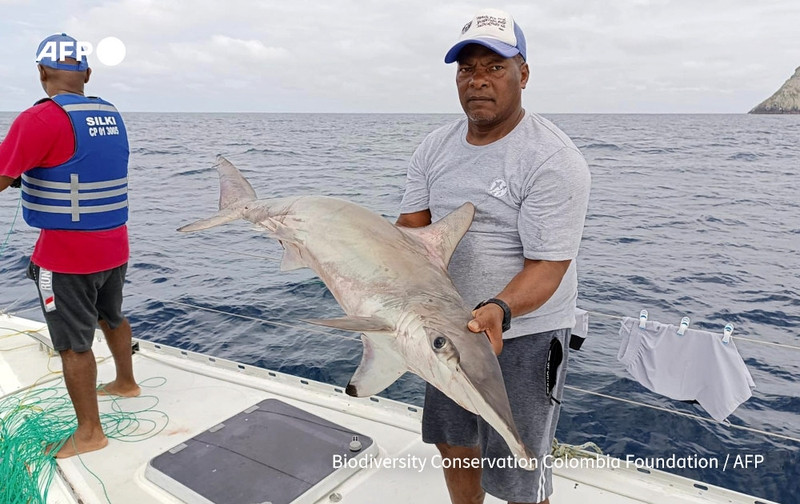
[345,334,406,397]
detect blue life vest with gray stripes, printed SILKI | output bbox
[22,94,129,231]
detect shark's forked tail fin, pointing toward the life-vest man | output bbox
[178,156,257,232]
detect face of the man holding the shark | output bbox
[456,44,528,126]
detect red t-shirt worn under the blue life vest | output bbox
[0,97,129,274]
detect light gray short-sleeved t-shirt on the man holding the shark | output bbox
[400,112,591,338]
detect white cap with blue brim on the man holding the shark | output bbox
[444,9,528,63]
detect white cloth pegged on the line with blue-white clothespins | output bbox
[617,317,755,422]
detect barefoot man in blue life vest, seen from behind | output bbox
[0,33,140,458]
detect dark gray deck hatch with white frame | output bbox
[145,399,378,504]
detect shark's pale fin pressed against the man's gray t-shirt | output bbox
[398,203,475,269]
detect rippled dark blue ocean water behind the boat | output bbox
[0,113,800,503]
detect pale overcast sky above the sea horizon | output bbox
[0,0,800,113]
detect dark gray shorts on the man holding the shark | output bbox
[422,329,571,502]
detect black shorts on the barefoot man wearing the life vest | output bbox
[28,263,128,352]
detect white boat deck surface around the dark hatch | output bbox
[0,315,768,504]
